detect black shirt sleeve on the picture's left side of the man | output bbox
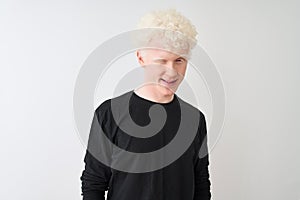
[80,110,111,200]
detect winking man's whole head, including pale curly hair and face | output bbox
[136,9,197,94]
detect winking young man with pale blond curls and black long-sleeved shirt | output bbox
[81,10,211,200]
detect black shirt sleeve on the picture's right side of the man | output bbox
[194,114,211,200]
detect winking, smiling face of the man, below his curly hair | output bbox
[137,49,187,95]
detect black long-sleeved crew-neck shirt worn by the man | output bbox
[80,90,211,200]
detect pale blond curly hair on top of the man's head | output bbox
[136,9,198,58]
